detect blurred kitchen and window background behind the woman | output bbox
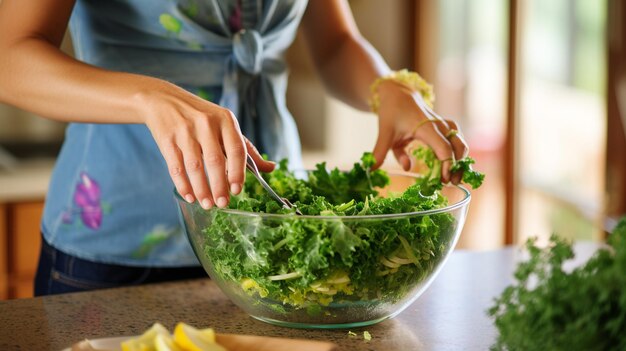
[0,0,626,299]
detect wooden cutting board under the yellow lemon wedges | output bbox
[68,333,338,351]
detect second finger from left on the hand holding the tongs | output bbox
[179,137,214,209]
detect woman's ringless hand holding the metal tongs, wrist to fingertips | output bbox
[137,82,275,209]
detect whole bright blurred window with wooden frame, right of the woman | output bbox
[416,0,608,248]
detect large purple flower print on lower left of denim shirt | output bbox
[74,172,102,229]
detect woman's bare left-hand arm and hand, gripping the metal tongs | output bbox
[0,0,273,208]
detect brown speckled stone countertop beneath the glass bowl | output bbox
[0,243,598,351]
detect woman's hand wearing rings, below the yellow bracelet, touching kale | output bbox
[373,80,469,184]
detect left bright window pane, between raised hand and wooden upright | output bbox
[425,0,508,249]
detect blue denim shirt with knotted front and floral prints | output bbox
[41,0,307,266]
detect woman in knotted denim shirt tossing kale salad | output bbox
[0,0,467,295]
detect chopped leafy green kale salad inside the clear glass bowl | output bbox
[203,148,483,314]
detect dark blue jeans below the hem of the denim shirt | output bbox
[35,235,208,296]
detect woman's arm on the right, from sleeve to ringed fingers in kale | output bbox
[303,0,468,183]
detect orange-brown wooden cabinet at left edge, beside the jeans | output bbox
[0,200,43,299]
